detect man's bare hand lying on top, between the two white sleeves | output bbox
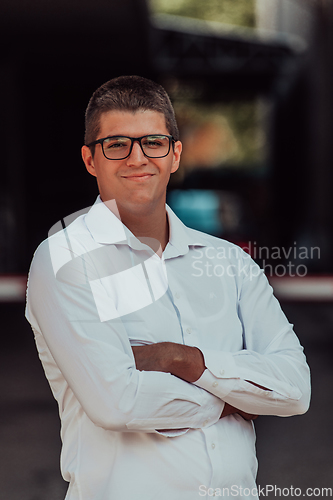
[132,342,205,382]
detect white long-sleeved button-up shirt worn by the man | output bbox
[27,199,310,500]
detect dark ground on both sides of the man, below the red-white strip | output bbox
[0,298,333,500]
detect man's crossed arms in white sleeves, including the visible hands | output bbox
[27,235,309,432]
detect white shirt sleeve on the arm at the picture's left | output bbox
[26,242,224,436]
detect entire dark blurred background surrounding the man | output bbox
[0,0,333,500]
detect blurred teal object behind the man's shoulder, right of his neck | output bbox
[167,189,223,236]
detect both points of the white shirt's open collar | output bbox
[85,196,207,259]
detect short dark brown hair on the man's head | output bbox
[84,76,179,149]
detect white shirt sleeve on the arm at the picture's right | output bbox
[195,258,310,416]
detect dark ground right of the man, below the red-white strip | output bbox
[256,304,333,498]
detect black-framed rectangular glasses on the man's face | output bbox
[87,134,175,160]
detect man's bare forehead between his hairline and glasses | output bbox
[99,109,169,137]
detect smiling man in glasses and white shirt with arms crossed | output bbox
[27,77,310,500]
